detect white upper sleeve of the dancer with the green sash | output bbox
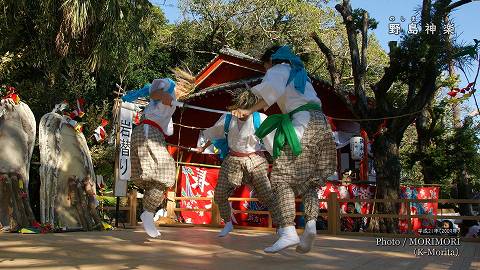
[252,64,290,107]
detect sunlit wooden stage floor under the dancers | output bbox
[0,227,480,270]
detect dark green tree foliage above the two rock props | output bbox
[0,0,173,190]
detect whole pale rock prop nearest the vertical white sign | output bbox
[39,111,102,230]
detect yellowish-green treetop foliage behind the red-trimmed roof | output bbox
[178,0,388,83]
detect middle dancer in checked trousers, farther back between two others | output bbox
[197,90,276,237]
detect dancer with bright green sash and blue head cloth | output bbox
[232,46,337,253]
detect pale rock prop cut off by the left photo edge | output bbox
[0,94,36,231]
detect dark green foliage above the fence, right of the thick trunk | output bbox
[400,106,480,198]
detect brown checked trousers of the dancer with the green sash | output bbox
[270,111,337,227]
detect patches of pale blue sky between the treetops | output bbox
[150,0,480,114]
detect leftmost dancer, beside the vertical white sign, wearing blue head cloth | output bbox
[122,78,176,237]
